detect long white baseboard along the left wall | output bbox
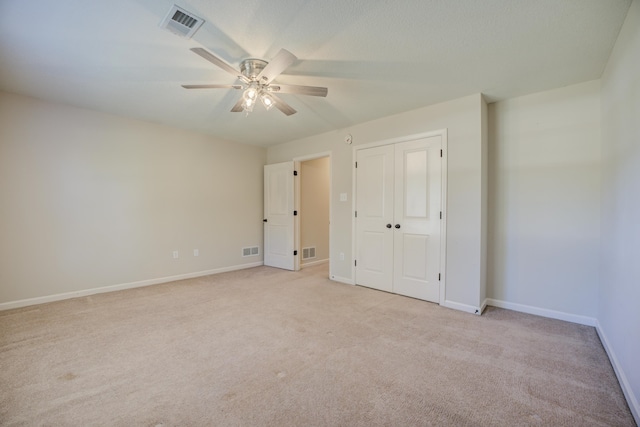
[0,261,263,311]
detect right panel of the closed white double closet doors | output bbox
[393,136,442,302]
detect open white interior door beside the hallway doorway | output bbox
[264,162,295,270]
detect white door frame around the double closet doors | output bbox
[351,128,449,305]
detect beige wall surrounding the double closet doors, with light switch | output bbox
[267,94,486,312]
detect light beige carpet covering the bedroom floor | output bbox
[0,265,635,426]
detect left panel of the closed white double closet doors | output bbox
[356,145,394,292]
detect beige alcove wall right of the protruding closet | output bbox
[488,81,601,319]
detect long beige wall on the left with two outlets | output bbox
[0,92,266,303]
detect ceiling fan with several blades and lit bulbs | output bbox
[182,47,328,116]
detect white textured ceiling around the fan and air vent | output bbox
[0,0,631,146]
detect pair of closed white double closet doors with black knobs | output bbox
[355,135,442,302]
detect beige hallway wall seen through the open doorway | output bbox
[300,157,331,265]
